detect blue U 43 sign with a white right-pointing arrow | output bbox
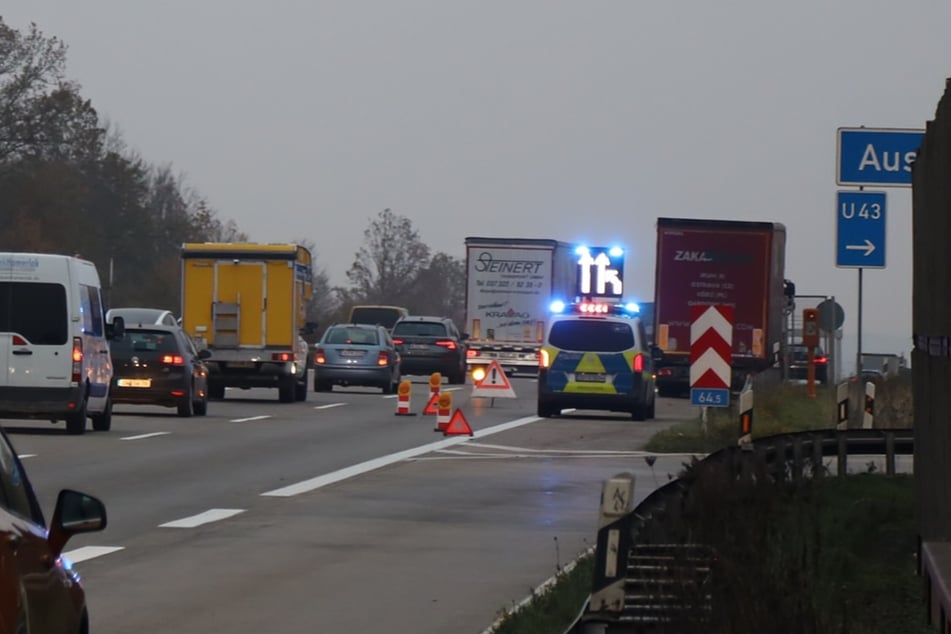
[835,191,885,269]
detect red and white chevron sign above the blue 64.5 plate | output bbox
[690,305,733,389]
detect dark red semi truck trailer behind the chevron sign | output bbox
[654,218,786,396]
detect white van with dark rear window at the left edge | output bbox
[0,253,124,434]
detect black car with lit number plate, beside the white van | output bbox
[110,324,211,416]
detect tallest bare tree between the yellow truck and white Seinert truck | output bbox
[347,208,429,306]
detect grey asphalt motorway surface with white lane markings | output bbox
[4,377,697,634]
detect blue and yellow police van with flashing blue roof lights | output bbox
[538,300,654,421]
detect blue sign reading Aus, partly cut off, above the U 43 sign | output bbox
[835,128,925,187]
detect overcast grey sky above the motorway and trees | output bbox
[0,0,951,370]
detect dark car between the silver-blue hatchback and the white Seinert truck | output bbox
[393,315,469,384]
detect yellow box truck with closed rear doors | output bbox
[182,242,313,403]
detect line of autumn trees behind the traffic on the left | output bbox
[0,17,465,336]
